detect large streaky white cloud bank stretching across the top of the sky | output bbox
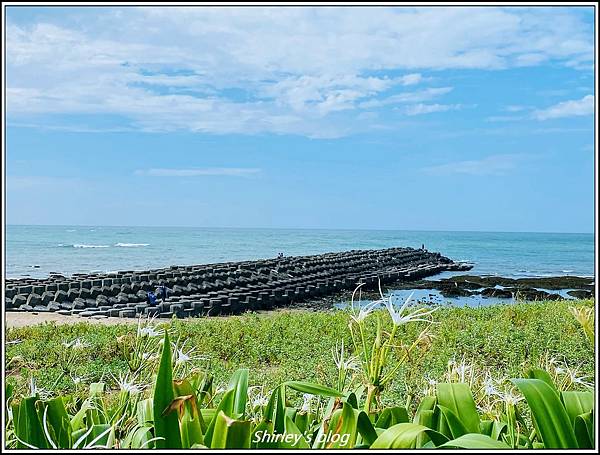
[6,7,593,137]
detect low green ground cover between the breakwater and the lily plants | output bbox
[6,300,594,402]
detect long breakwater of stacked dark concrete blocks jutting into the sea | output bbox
[5,248,470,318]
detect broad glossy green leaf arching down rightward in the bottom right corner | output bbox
[512,379,578,449]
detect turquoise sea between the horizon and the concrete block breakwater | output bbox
[5,225,594,277]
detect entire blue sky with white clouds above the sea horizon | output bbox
[5,6,595,232]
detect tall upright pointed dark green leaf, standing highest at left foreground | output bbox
[152,330,181,449]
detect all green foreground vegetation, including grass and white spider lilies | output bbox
[6,297,594,449]
